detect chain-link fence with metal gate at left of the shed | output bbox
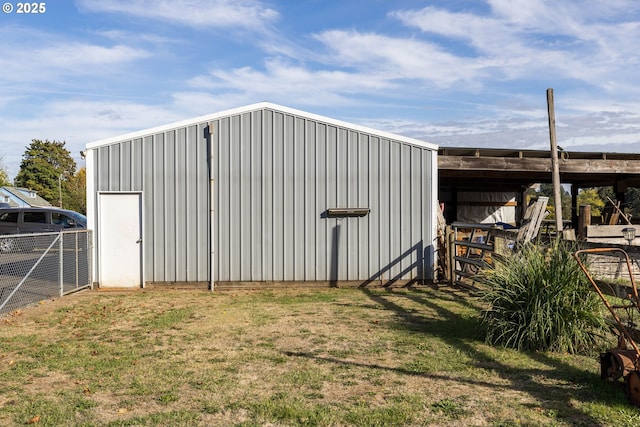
[0,230,93,315]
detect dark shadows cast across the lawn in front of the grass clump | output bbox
[287,288,623,425]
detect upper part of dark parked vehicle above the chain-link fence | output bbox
[0,207,87,252]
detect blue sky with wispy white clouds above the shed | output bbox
[0,0,640,177]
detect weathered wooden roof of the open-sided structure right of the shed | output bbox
[438,147,640,225]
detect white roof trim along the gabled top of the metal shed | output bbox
[86,102,438,150]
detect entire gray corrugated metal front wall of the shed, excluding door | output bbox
[93,108,437,288]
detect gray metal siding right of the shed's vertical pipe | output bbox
[212,109,436,282]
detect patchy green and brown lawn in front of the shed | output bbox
[0,288,640,426]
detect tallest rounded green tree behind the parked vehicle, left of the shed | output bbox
[15,139,76,206]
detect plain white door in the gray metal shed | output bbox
[97,193,142,288]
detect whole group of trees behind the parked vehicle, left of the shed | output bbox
[0,139,87,214]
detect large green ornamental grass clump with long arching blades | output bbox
[479,240,606,353]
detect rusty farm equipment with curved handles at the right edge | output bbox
[574,248,640,406]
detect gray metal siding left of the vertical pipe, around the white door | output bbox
[94,123,210,282]
